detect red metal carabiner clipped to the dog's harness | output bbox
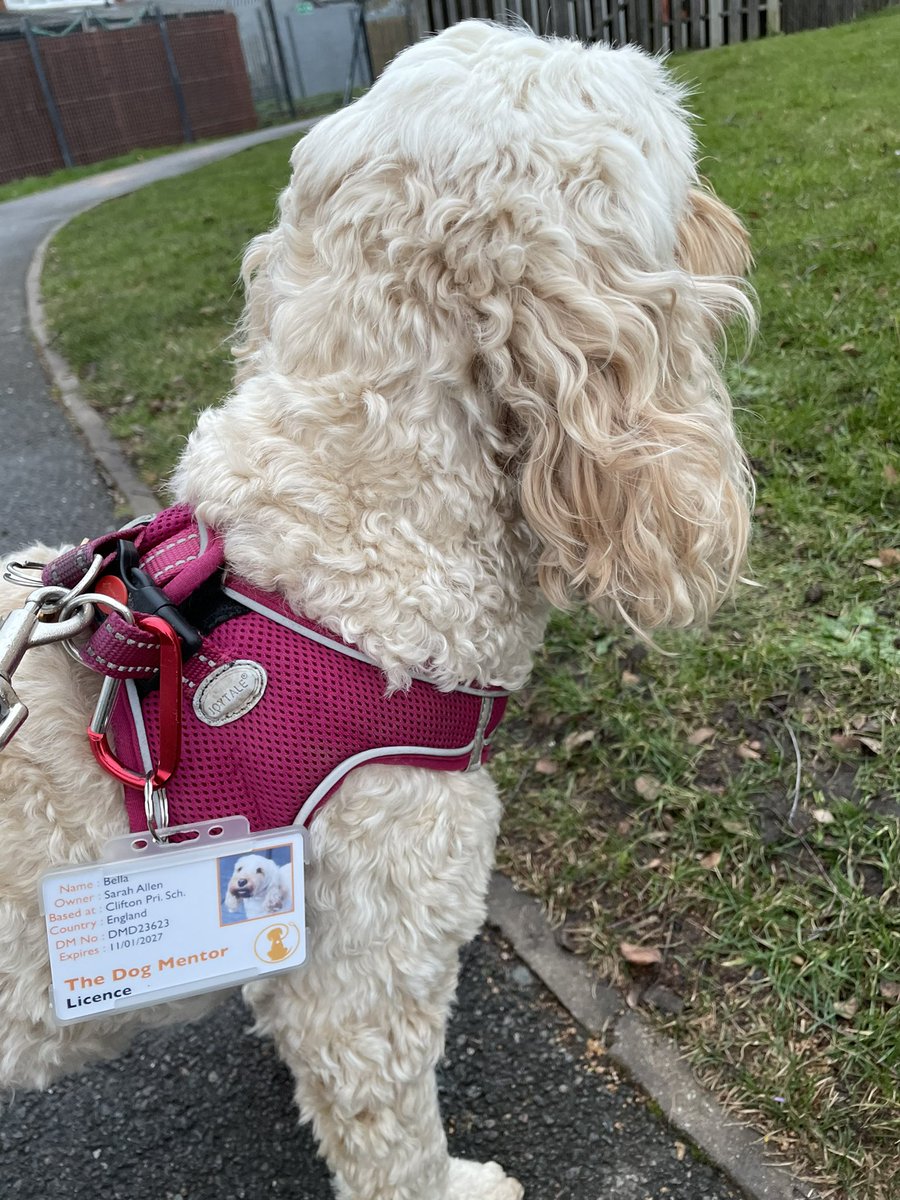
[88,612,181,792]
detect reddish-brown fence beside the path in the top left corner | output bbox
[0,10,257,184]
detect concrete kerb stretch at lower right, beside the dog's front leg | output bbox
[487,874,817,1200]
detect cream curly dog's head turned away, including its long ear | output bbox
[239,22,752,630]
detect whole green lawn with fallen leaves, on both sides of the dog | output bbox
[44,11,900,1200]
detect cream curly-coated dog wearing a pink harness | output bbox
[0,22,752,1200]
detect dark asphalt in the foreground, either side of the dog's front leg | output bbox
[0,934,738,1200]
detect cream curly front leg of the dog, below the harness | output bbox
[247,768,522,1200]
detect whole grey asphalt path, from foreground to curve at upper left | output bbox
[0,142,738,1200]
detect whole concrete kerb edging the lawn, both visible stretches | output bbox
[25,142,817,1200]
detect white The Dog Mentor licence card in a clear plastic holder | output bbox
[41,817,306,1022]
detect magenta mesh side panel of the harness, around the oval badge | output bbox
[107,580,506,832]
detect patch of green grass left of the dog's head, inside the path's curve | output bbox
[43,136,296,484]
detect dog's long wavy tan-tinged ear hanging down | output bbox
[481,201,752,631]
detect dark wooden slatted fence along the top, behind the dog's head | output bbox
[414,0,895,52]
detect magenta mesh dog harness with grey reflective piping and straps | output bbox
[43,505,508,832]
